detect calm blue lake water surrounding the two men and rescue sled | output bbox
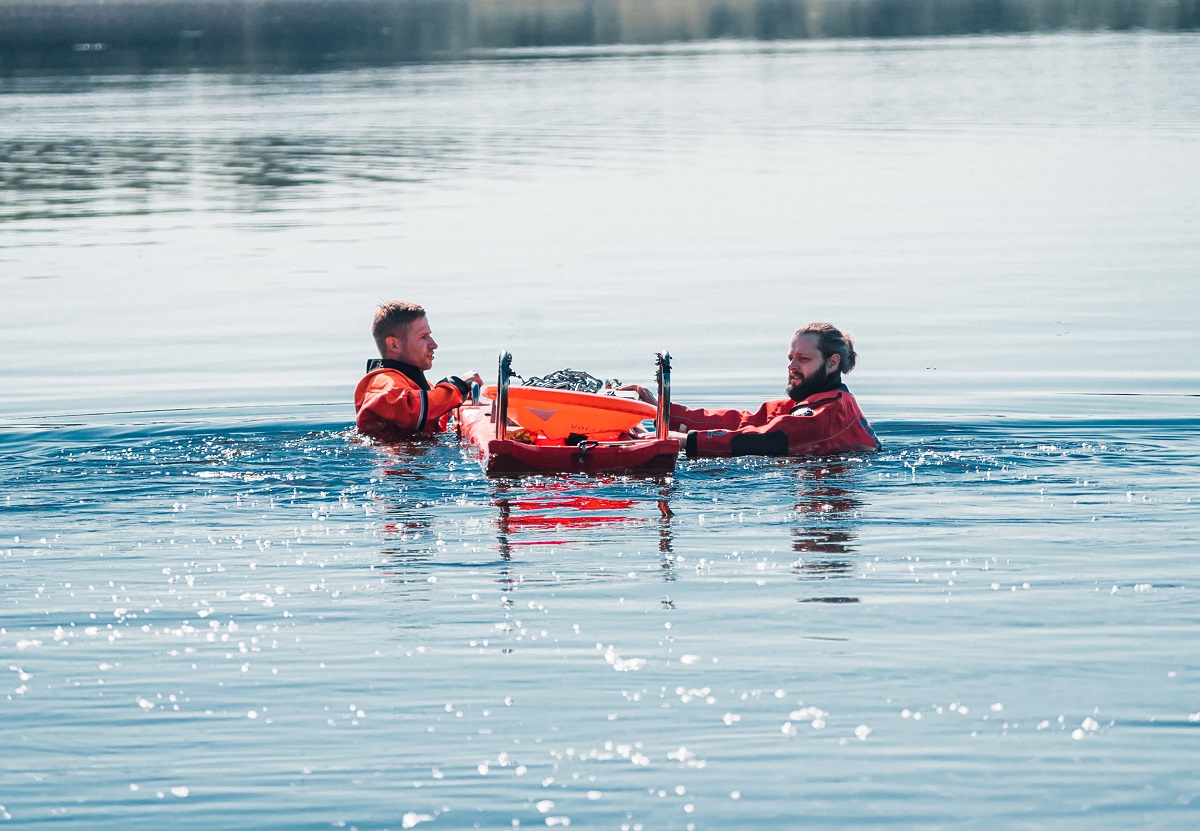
[0,35,1200,831]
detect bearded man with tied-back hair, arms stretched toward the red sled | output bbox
[634,323,880,458]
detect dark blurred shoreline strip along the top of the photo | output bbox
[0,0,1200,74]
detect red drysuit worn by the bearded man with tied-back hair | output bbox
[671,384,880,456]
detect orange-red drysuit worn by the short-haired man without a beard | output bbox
[354,360,470,442]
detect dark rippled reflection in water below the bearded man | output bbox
[792,464,862,603]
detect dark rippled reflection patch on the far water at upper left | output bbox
[0,131,468,220]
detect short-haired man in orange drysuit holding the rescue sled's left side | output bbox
[354,300,480,442]
